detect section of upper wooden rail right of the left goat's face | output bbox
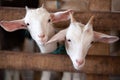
[54,12,120,30]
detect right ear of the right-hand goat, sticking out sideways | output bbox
[94,31,119,43]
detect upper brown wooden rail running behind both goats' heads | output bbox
[0,7,120,30]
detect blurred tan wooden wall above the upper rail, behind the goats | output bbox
[39,0,120,12]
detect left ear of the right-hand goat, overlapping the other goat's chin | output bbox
[46,29,67,44]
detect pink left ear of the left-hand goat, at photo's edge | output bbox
[0,19,27,32]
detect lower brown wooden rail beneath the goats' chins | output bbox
[0,51,120,75]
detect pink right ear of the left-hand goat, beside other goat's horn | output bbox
[50,10,73,23]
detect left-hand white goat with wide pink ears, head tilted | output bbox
[0,6,72,79]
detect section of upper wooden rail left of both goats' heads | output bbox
[0,7,25,20]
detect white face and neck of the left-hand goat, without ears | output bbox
[24,8,57,53]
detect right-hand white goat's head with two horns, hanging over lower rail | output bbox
[46,13,119,70]
